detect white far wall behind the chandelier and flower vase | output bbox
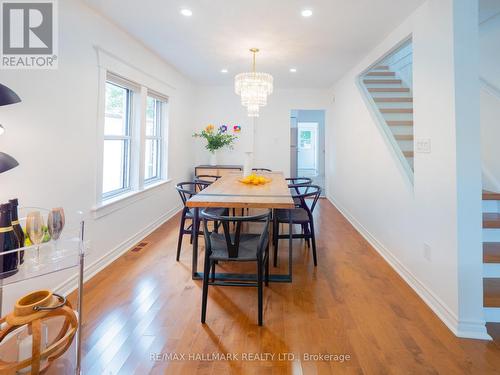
[195,86,332,175]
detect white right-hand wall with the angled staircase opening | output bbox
[326,0,488,338]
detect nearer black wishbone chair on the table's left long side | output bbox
[175,181,227,261]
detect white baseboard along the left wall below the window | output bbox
[54,206,182,296]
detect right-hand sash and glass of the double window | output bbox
[144,96,165,183]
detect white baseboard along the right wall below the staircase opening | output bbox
[328,195,491,340]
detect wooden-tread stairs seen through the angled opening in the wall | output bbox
[361,65,414,171]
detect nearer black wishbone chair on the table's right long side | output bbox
[273,184,321,267]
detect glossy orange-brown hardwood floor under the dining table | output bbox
[67,200,500,375]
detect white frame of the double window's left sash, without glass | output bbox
[101,79,134,201]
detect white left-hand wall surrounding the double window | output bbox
[0,0,194,309]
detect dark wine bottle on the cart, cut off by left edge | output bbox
[0,203,19,279]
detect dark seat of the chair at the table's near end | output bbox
[210,232,260,262]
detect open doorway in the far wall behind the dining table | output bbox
[290,110,325,193]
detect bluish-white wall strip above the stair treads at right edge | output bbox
[479,13,500,191]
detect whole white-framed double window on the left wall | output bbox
[98,73,168,201]
